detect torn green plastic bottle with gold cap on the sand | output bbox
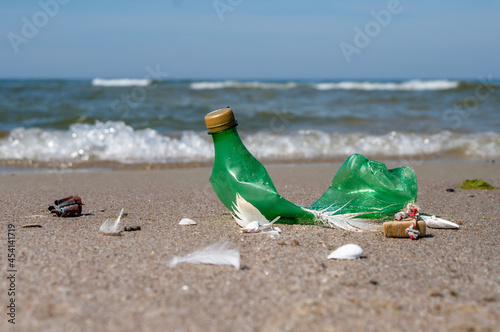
[205,108,417,224]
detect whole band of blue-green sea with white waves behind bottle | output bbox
[0,78,500,167]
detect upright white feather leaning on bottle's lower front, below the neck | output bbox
[233,194,281,237]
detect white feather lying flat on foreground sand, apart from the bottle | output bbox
[169,241,240,269]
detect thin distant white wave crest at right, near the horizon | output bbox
[313,80,460,91]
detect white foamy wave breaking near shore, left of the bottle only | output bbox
[0,121,213,163]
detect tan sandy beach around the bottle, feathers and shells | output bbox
[0,162,500,332]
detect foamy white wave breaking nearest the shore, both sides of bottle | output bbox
[0,121,500,164]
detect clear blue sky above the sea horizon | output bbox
[0,0,500,80]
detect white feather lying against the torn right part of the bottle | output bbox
[304,201,382,232]
